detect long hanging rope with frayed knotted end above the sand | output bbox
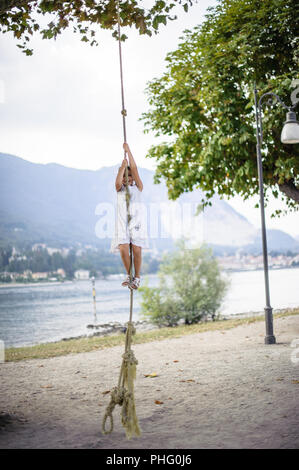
[102,0,141,439]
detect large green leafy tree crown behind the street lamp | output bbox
[143,0,299,215]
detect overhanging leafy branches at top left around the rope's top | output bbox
[0,0,196,55]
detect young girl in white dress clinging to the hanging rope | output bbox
[111,143,147,289]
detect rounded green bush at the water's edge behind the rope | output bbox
[140,242,228,326]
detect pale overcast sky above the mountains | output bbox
[0,0,299,236]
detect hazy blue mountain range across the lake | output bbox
[0,153,299,253]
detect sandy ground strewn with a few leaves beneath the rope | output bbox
[0,316,299,449]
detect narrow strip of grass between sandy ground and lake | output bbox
[5,308,299,362]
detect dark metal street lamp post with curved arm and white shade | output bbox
[254,87,299,344]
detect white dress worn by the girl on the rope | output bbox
[110,184,148,253]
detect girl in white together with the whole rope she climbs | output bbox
[102,0,146,439]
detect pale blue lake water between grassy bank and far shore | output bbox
[0,268,299,347]
